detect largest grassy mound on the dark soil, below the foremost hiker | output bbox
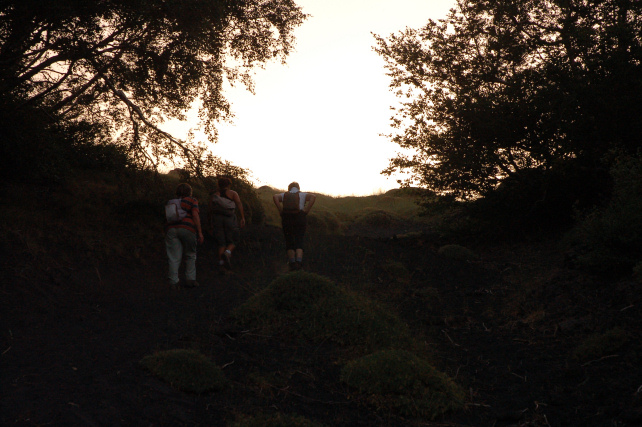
[234,271,411,351]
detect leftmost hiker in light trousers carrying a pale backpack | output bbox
[165,183,204,288]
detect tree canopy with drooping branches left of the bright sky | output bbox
[0,0,305,176]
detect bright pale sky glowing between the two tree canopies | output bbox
[202,0,455,196]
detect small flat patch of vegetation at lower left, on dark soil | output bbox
[140,349,228,393]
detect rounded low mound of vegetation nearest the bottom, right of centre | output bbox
[341,350,464,419]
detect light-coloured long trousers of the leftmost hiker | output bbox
[165,228,196,285]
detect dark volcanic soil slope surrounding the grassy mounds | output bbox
[0,227,642,426]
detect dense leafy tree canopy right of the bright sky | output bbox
[375,0,642,197]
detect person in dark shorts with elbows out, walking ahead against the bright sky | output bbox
[272,182,316,271]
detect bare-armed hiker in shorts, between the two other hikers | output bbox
[210,178,245,270]
